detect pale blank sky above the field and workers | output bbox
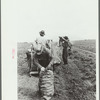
[3,0,98,42]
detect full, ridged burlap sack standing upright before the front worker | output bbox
[39,70,54,100]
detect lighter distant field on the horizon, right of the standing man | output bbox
[73,40,96,53]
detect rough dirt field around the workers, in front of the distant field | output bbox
[17,39,96,100]
